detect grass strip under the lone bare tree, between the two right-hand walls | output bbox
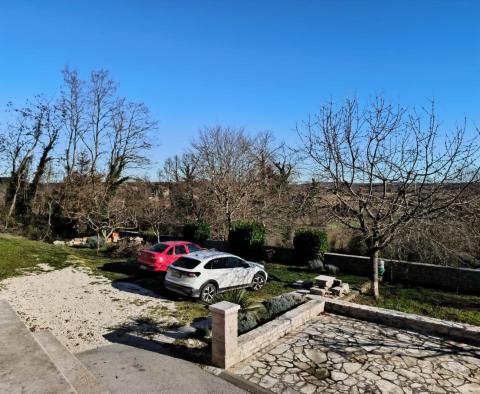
[354,282,480,326]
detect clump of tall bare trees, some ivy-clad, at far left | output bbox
[0,67,156,240]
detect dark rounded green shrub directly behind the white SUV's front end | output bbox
[228,220,267,260]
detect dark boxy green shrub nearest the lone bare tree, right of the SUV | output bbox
[293,229,328,265]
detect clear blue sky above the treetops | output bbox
[0,0,480,175]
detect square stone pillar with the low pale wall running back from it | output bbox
[210,299,325,368]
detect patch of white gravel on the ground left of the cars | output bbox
[0,265,175,353]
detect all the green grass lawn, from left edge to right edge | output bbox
[0,234,480,336]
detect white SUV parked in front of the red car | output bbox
[165,250,268,303]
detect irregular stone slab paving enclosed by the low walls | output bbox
[231,314,480,394]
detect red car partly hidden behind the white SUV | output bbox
[137,241,203,272]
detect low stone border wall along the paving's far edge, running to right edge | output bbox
[325,299,480,346]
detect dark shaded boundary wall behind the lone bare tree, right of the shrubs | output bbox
[325,253,480,294]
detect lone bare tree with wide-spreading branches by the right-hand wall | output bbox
[298,98,479,297]
